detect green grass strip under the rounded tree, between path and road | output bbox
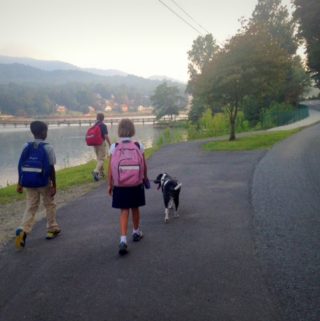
[203,129,299,152]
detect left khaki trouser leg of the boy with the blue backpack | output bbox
[21,188,40,234]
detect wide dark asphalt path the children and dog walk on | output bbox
[0,124,319,321]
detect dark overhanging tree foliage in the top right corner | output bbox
[293,0,320,88]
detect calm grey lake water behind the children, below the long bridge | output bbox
[0,124,162,188]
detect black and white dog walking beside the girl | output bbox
[154,173,182,223]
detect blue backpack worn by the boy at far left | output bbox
[18,142,51,187]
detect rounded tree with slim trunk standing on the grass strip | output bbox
[200,30,290,140]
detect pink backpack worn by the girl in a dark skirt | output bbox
[111,141,144,187]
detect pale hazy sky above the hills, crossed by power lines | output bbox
[0,0,290,81]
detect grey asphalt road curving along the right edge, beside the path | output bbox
[252,124,320,321]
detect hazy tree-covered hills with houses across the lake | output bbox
[0,64,185,116]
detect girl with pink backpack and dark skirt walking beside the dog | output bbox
[108,119,149,255]
